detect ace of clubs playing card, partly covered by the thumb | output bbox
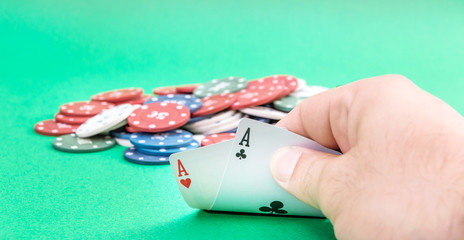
[211,119,340,217]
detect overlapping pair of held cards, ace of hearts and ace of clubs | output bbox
[169,119,340,217]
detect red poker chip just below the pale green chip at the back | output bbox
[192,93,238,117]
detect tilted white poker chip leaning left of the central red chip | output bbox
[76,104,134,138]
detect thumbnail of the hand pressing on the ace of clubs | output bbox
[271,147,301,184]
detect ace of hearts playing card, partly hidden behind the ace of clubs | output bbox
[169,140,233,209]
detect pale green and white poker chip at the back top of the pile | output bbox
[193,77,248,98]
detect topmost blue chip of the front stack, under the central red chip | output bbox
[130,129,193,148]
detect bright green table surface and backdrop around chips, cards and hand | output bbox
[0,0,464,239]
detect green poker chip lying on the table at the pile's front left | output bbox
[53,133,116,153]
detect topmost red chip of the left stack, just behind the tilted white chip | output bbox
[60,102,114,117]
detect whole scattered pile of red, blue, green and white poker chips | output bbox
[34,75,327,165]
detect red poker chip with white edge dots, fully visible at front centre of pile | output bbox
[127,102,190,132]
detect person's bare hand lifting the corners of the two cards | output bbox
[271,75,464,239]
